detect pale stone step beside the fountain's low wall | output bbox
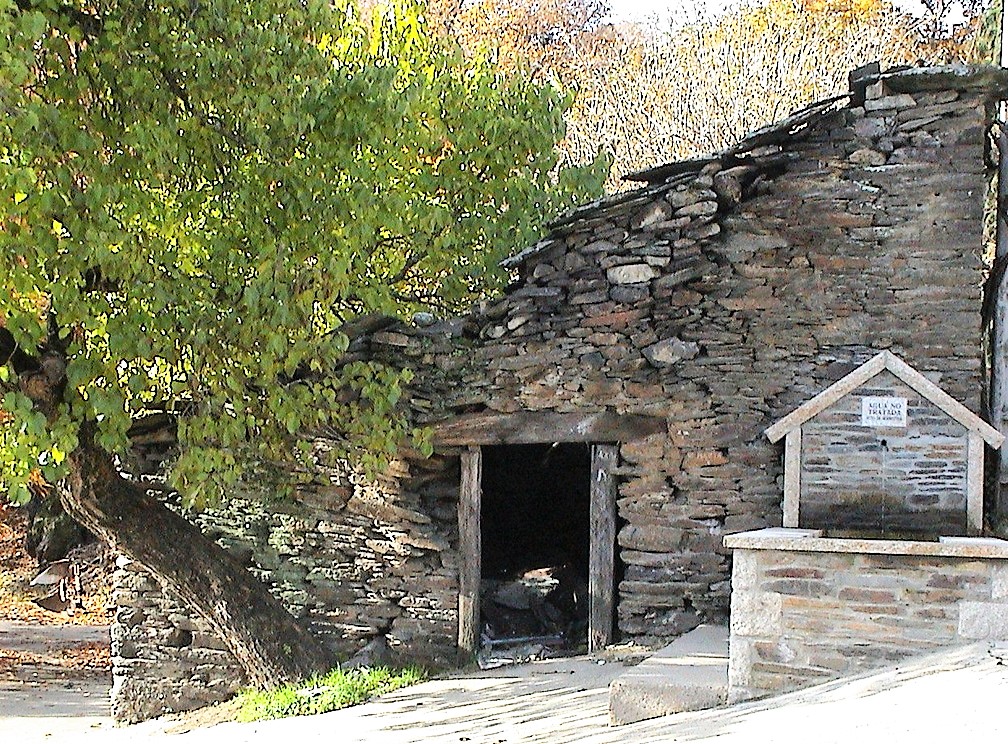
[609,625,728,725]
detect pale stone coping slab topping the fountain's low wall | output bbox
[724,527,1008,560]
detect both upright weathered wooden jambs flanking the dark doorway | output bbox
[459,444,619,659]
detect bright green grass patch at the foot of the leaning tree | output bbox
[237,666,426,721]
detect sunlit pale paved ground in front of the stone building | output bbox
[0,625,1008,744]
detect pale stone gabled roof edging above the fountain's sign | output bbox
[763,351,1005,450]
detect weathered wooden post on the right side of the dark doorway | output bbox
[588,445,619,652]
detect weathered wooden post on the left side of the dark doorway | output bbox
[459,447,483,658]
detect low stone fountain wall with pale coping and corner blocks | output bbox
[725,528,1008,703]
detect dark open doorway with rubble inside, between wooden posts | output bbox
[480,444,592,649]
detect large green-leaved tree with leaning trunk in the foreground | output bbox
[0,0,603,683]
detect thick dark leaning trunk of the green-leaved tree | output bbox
[59,424,334,686]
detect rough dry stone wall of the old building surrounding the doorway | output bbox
[112,70,1008,717]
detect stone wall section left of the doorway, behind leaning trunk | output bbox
[112,449,459,723]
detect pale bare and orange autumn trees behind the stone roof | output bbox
[432,0,987,191]
